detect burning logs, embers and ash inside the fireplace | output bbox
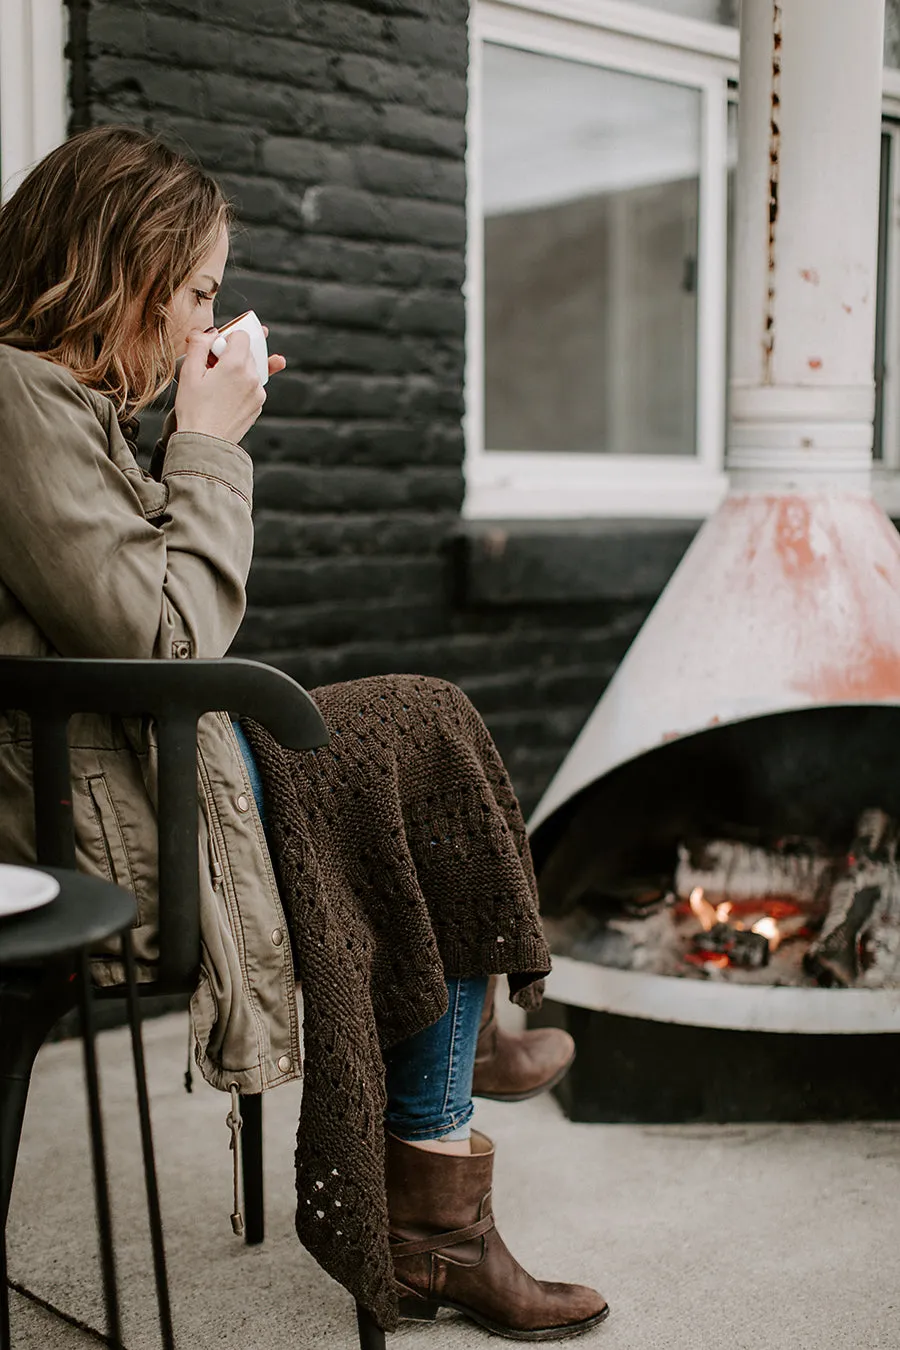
[545,809,900,990]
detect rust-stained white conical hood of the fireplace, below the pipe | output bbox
[529,491,900,832]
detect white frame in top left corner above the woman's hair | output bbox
[0,0,69,201]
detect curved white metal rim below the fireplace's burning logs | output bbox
[546,956,900,1035]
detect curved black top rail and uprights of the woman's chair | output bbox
[0,656,328,992]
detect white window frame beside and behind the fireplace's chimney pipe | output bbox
[472,0,900,520]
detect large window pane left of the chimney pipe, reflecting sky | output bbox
[482,43,702,455]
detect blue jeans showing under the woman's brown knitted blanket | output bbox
[232,718,487,1139]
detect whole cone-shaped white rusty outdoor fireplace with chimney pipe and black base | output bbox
[530,0,900,1119]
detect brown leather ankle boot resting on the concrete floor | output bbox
[387,1133,610,1341]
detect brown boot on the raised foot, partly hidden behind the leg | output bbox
[472,975,575,1102]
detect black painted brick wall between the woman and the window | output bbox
[70,0,649,809]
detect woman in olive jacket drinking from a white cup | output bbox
[0,127,607,1341]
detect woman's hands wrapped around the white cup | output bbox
[175,331,285,444]
